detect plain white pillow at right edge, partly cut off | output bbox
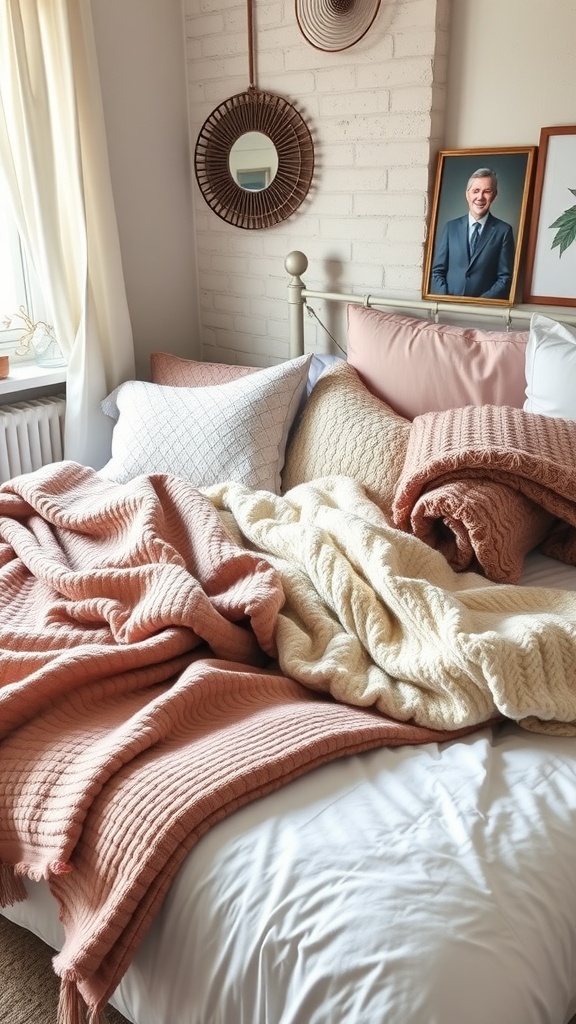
[524,313,576,420]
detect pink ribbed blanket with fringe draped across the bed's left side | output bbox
[0,463,461,1024]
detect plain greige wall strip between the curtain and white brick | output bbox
[92,0,200,377]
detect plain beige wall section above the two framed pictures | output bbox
[444,0,576,150]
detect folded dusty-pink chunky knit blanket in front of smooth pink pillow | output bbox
[393,406,576,583]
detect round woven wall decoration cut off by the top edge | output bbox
[295,0,380,52]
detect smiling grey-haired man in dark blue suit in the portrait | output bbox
[430,167,516,299]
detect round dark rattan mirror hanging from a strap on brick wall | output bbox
[195,0,314,228]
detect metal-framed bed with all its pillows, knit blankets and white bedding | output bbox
[0,254,576,1024]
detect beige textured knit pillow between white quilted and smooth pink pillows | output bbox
[282,362,410,516]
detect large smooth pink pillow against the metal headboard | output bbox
[347,305,529,420]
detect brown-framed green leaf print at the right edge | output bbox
[524,125,576,306]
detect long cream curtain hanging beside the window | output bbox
[0,0,134,468]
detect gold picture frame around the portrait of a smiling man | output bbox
[422,145,536,306]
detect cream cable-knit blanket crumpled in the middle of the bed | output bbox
[210,477,576,735]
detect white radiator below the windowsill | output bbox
[0,395,66,483]
